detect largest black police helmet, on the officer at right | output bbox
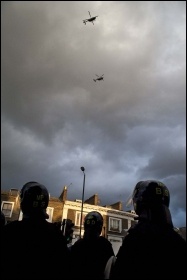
[132,180,170,215]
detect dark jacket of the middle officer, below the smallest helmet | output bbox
[71,236,114,279]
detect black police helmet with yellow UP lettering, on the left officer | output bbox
[20,182,49,219]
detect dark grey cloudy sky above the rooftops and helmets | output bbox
[1,1,186,226]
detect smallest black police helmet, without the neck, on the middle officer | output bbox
[84,211,103,232]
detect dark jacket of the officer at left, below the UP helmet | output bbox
[1,219,69,280]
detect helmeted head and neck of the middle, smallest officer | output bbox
[84,211,103,237]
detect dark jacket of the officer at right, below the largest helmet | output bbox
[111,221,186,280]
